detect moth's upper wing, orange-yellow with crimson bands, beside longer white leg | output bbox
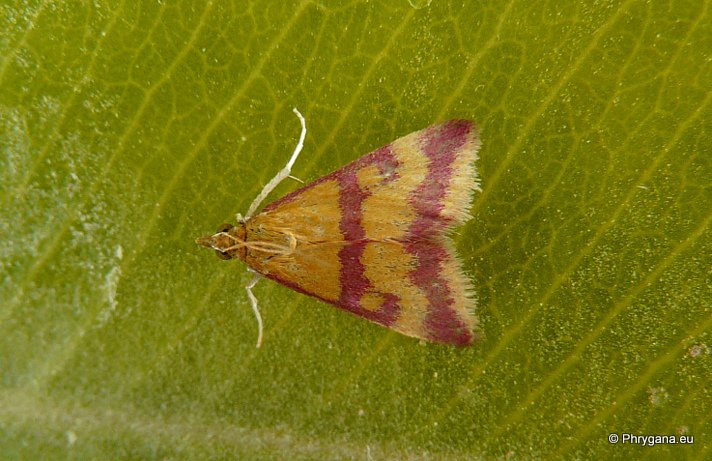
[263,120,480,240]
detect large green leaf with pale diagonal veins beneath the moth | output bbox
[0,0,712,460]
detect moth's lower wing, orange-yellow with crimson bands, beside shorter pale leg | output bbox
[249,241,475,345]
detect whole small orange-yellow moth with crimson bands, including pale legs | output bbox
[196,109,480,347]
